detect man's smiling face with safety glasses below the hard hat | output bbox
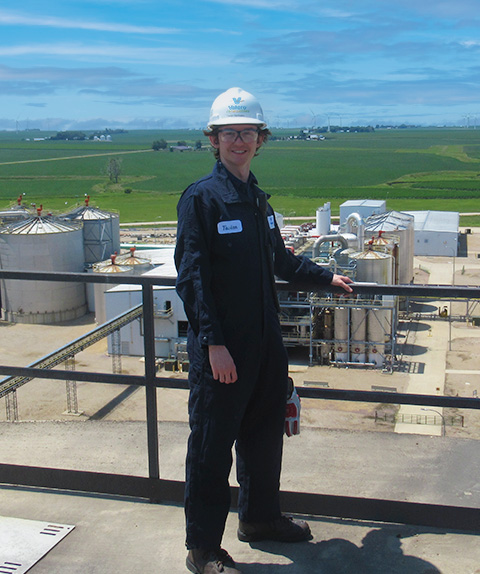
[209,124,263,175]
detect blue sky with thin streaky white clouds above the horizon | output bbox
[0,0,480,130]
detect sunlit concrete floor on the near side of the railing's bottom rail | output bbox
[0,487,480,574]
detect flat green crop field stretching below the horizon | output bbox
[0,128,480,226]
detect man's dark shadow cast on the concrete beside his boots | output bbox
[238,528,441,574]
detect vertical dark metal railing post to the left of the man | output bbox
[142,283,160,498]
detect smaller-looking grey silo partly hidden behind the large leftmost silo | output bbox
[62,196,120,264]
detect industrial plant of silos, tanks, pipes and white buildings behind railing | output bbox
[0,197,458,378]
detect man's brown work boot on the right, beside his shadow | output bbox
[237,516,312,542]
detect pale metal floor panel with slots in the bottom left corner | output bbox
[0,516,75,574]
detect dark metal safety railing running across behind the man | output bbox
[0,270,480,530]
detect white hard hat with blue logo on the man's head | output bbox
[207,88,267,130]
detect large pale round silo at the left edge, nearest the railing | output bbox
[0,209,86,324]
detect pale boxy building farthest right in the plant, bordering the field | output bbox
[406,211,460,257]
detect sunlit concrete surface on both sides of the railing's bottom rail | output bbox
[0,421,480,574]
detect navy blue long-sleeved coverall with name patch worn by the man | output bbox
[175,161,333,549]
